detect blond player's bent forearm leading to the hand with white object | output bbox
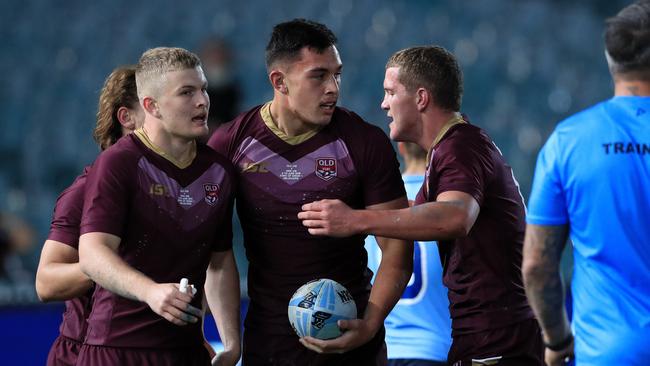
[79,233,155,302]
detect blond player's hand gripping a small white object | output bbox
[145,283,201,325]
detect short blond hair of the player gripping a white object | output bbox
[135,47,201,99]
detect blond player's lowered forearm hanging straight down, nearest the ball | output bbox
[205,251,241,354]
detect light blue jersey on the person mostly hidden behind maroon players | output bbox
[366,175,451,361]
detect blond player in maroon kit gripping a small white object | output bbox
[77,47,240,365]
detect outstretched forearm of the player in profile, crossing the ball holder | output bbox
[350,202,467,241]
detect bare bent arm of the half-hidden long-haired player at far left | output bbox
[36,239,93,302]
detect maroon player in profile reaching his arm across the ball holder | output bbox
[299,46,543,366]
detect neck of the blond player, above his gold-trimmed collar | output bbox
[139,123,196,168]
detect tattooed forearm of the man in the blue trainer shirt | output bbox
[522,225,570,344]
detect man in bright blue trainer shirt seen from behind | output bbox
[524,1,650,366]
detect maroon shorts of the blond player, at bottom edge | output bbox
[77,344,211,366]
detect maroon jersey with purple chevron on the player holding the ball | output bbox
[208,104,405,334]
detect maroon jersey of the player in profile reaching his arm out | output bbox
[415,123,533,335]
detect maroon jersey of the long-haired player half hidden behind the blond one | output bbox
[47,167,94,343]
